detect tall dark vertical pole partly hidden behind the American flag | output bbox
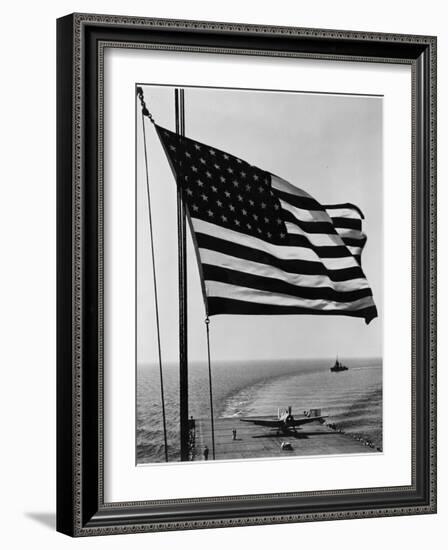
[174,88,190,460]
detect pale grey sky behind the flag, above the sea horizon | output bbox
[136,85,383,364]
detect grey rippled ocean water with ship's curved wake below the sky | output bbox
[136,359,382,464]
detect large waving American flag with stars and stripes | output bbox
[155,125,377,323]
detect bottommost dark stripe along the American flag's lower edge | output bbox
[208,296,377,322]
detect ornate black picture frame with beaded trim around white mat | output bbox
[57,14,436,536]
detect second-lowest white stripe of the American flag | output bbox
[200,248,369,292]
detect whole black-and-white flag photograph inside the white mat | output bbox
[135,82,384,466]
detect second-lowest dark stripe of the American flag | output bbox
[202,263,372,303]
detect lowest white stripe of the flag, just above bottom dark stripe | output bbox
[205,281,373,311]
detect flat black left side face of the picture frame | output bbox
[56,16,76,535]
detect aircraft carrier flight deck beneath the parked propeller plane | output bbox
[191,418,381,460]
